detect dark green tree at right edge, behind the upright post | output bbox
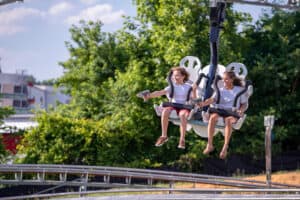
[232,11,300,157]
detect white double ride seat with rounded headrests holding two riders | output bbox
[154,56,253,137]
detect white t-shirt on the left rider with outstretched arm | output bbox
[164,83,191,104]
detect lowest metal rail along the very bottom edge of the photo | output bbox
[0,188,300,200]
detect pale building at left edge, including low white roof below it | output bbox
[0,70,70,133]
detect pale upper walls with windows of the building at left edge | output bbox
[0,73,70,114]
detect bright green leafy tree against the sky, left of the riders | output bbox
[58,21,128,118]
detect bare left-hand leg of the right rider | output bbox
[203,113,219,154]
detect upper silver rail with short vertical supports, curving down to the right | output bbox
[0,164,300,188]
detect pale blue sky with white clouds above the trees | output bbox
[0,0,268,81]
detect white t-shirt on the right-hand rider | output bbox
[212,86,247,110]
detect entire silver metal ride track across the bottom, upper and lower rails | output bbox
[0,164,300,199]
